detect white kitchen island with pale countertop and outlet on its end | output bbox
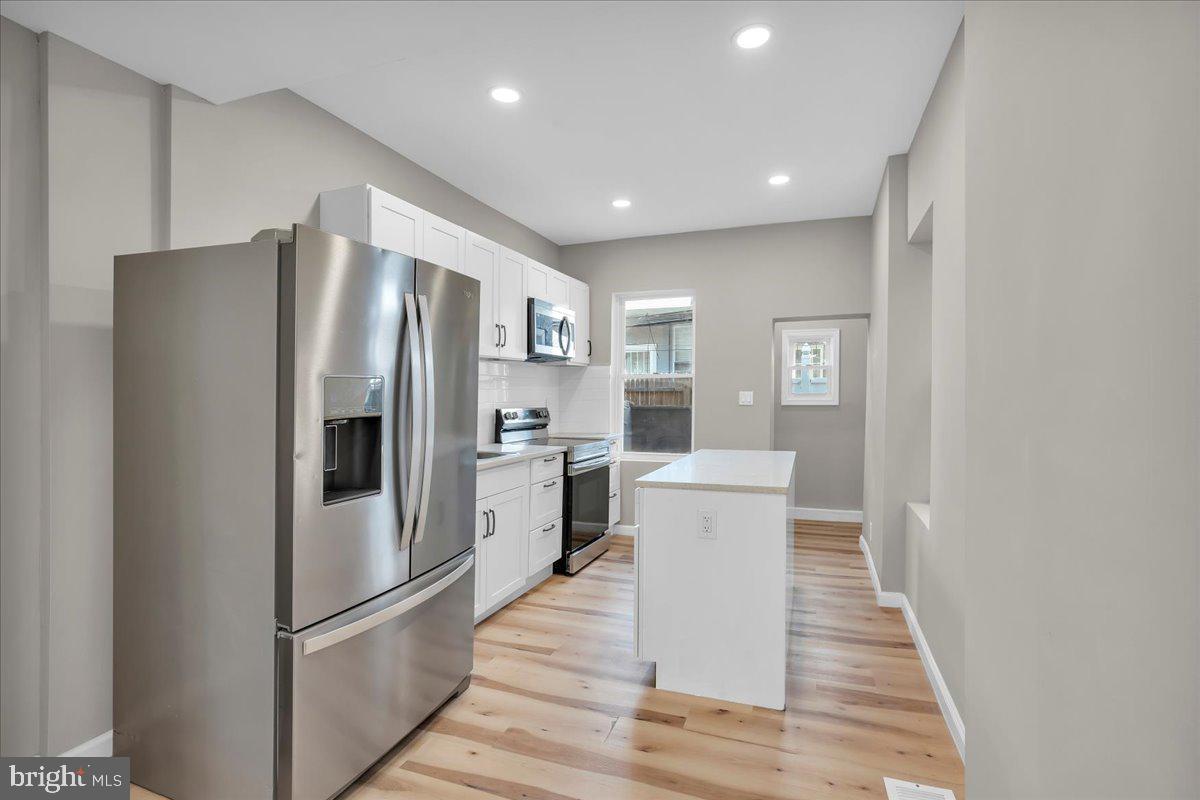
[635,450,796,709]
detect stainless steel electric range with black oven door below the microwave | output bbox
[496,408,612,575]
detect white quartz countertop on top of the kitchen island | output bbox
[636,450,796,494]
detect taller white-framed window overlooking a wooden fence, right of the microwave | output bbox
[614,293,695,453]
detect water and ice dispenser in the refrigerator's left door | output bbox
[322,375,383,505]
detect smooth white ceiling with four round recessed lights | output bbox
[0,0,962,245]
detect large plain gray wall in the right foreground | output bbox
[964,2,1200,800]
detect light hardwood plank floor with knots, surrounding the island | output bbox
[138,522,964,800]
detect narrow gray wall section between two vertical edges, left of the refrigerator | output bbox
[42,29,166,753]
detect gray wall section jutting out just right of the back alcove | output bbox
[863,156,936,594]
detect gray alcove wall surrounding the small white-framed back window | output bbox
[768,317,866,511]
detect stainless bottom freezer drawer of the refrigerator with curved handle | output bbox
[276,549,475,800]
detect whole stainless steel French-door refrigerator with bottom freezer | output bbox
[113,225,479,800]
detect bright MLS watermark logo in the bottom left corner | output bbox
[0,757,130,800]
